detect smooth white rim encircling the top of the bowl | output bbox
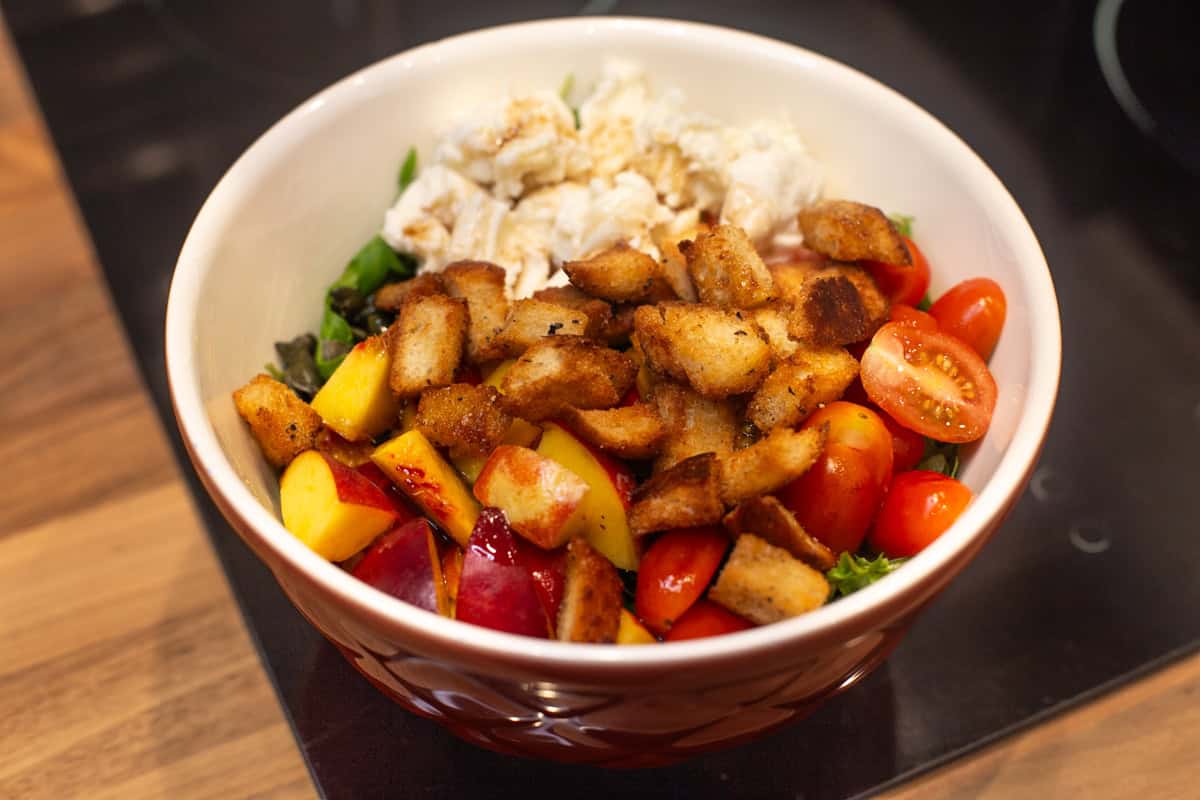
[164,17,1062,676]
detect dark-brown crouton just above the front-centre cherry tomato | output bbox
[629,453,725,536]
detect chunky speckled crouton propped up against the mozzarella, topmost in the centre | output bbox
[679,225,775,308]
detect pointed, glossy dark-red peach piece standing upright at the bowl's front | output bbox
[455,509,550,638]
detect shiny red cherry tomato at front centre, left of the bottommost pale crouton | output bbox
[634,528,730,634]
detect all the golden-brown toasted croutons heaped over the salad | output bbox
[238,200,911,630]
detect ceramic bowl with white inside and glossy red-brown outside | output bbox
[167,18,1061,764]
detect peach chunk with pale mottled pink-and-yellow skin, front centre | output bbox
[475,445,589,551]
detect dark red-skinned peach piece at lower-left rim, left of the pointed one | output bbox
[352,519,442,614]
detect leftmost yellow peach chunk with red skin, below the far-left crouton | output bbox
[280,450,396,561]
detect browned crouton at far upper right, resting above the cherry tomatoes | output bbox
[799,200,912,265]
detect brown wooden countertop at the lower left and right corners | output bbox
[0,17,1200,799]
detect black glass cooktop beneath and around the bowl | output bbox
[11,0,1200,799]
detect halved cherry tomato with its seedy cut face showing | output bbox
[859,323,996,443]
